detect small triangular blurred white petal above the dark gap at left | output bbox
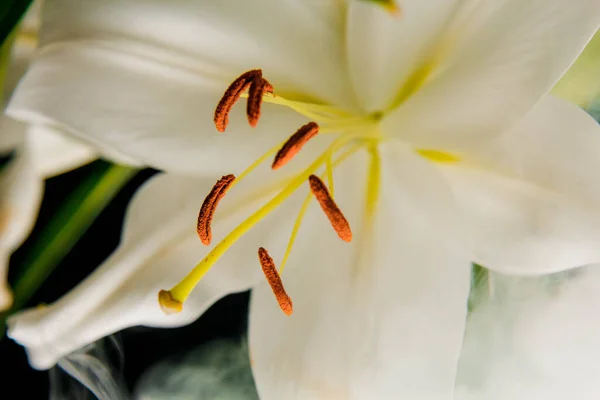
[27,125,97,177]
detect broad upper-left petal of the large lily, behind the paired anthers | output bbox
[8,0,353,174]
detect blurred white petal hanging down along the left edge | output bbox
[0,146,43,310]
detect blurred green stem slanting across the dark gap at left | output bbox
[8,161,137,315]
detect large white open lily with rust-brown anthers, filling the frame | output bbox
[9,0,600,400]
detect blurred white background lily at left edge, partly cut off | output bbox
[0,1,97,310]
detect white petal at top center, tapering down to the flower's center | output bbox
[346,0,457,112]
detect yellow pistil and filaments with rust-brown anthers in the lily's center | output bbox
[158,69,458,315]
